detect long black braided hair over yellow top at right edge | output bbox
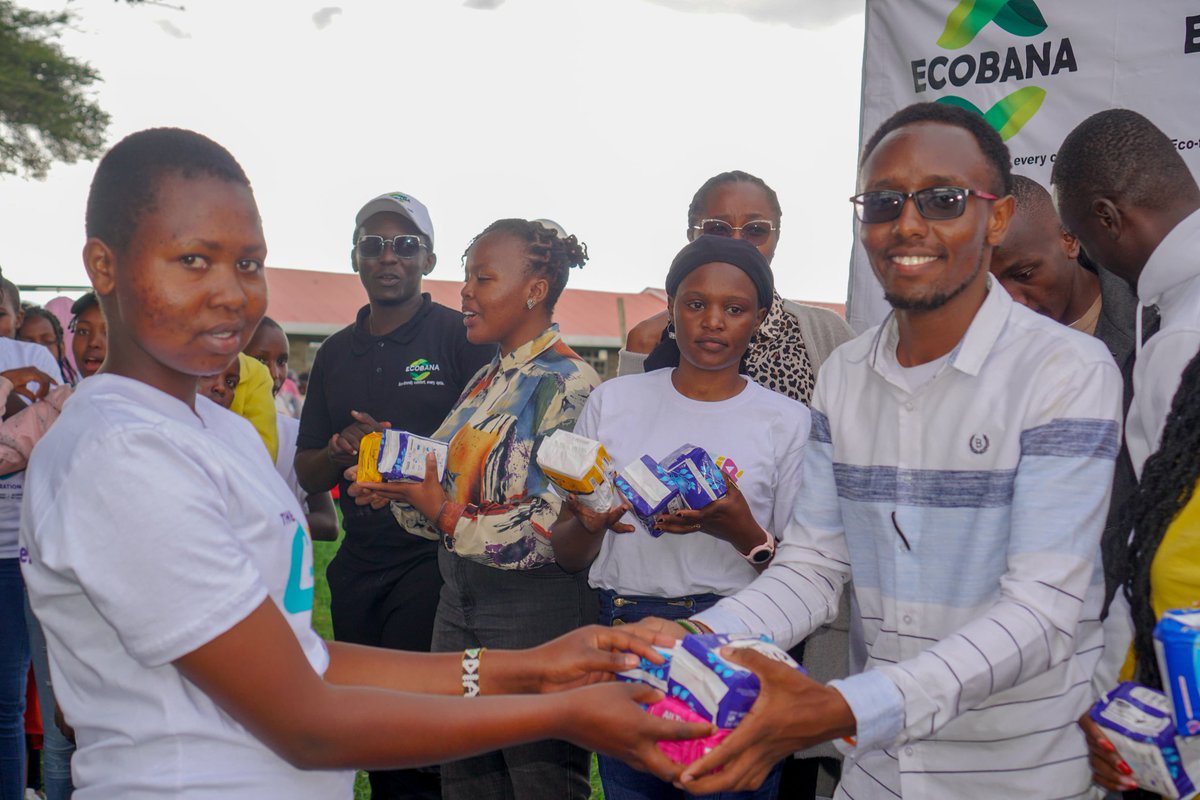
[1122,345,1200,688]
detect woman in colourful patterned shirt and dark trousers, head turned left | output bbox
[350,219,600,800]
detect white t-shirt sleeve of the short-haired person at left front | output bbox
[46,431,268,667]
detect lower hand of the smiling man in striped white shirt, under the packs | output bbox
[677,649,857,794]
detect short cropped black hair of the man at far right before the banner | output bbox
[1050,108,1200,210]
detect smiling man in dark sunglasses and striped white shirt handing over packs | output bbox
[648,103,1121,800]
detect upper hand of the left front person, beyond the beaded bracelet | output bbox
[528,625,678,692]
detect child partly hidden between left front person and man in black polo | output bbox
[242,317,337,542]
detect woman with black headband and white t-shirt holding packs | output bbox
[551,235,810,799]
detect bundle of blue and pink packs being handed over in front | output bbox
[617,633,804,764]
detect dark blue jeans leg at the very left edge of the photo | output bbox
[0,559,29,800]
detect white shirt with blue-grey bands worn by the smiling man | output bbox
[698,278,1121,799]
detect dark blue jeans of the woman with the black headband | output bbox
[596,589,782,800]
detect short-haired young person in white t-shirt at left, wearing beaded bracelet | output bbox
[20,128,708,800]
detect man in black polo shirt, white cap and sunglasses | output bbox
[295,192,496,800]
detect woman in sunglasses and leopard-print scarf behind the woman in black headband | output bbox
[618,170,854,404]
